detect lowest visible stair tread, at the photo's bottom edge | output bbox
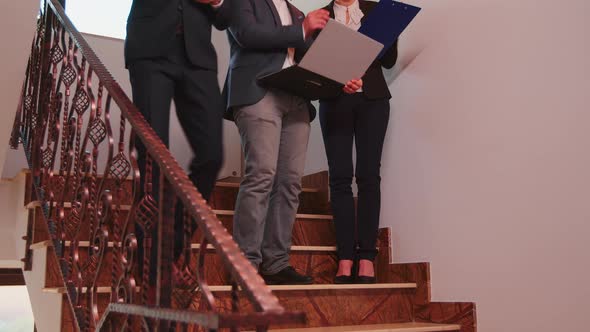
[271,322,461,332]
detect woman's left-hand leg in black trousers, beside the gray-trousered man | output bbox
[320,96,360,275]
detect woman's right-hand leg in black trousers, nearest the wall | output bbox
[355,99,390,276]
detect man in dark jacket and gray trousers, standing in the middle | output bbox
[224,0,364,284]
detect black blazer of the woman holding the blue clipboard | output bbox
[324,0,397,99]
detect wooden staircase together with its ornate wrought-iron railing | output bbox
[10,0,476,332]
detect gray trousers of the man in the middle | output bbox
[233,91,310,274]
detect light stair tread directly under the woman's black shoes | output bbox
[43,283,418,294]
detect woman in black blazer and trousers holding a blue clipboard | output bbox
[320,0,397,283]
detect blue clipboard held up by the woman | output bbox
[359,0,421,58]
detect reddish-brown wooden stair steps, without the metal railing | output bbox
[25,172,476,332]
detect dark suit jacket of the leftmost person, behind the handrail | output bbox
[125,0,231,71]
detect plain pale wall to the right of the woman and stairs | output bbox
[381,0,590,332]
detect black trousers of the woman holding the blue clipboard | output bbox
[320,93,390,260]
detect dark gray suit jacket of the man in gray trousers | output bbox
[223,0,315,120]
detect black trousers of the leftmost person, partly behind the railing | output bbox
[129,35,224,280]
